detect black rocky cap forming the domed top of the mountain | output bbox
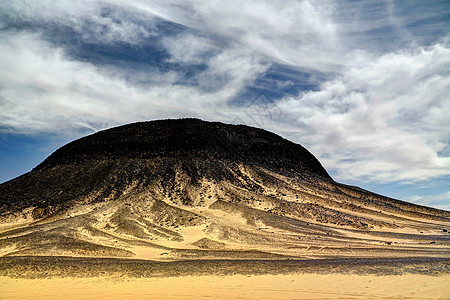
[36,119,331,179]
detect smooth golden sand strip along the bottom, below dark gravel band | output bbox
[0,274,450,299]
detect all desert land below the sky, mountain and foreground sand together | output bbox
[0,119,450,299]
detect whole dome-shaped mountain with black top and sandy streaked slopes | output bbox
[0,119,450,261]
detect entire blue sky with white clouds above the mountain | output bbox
[0,0,450,210]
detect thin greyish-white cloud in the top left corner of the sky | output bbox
[0,0,154,44]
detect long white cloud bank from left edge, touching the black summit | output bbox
[0,34,266,133]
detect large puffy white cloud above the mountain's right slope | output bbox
[278,43,450,182]
